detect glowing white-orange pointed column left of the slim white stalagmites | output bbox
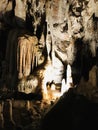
[42,60,60,101]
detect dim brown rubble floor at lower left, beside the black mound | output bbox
[0,99,50,130]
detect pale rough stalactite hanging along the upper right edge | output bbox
[82,0,98,57]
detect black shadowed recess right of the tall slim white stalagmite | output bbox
[71,38,98,85]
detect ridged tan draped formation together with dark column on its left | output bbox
[2,29,45,90]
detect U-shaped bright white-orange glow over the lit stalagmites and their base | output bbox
[42,60,73,101]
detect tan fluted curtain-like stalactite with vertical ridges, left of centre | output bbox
[17,35,38,79]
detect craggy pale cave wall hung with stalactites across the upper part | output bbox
[0,0,98,95]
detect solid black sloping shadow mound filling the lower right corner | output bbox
[42,89,98,130]
